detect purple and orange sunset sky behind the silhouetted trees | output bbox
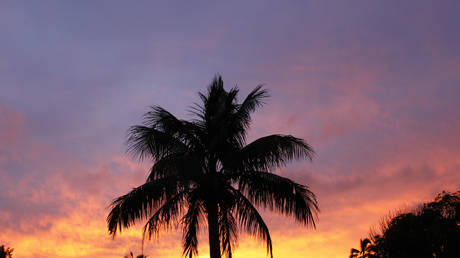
[0,0,460,258]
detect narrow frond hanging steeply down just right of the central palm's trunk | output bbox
[231,187,273,258]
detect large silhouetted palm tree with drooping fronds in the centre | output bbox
[107,76,318,258]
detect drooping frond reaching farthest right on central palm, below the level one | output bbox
[234,171,319,227]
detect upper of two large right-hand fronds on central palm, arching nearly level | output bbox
[233,134,315,171]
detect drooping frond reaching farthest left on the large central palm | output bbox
[107,178,182,237]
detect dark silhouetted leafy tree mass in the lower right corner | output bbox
[350,191,460,258]
